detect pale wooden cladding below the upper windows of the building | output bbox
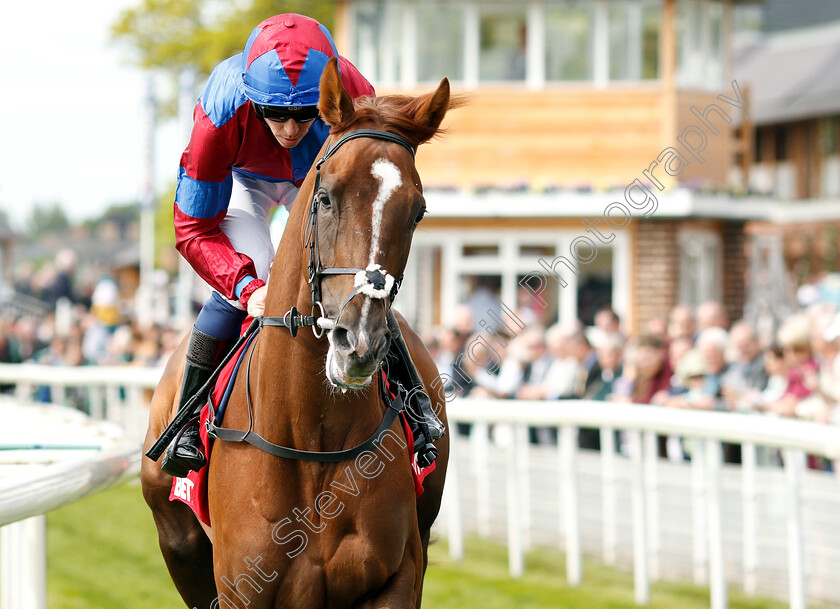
[394,86,737,188]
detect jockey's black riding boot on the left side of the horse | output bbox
[160,326,225,478]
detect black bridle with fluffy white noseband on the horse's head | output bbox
[261,129,415,338]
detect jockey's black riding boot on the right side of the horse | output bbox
[387,311,446,467]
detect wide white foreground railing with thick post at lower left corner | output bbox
[0,398,141,609]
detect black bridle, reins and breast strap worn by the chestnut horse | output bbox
[207,129,414,463]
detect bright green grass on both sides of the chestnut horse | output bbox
[47,484,786,609]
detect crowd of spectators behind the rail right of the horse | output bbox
[426,302,840,462]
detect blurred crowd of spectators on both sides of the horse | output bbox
[6,256,840,470]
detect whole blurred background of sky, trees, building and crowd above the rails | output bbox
[0,0,840,602]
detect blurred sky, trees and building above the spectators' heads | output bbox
[0,0,840,370]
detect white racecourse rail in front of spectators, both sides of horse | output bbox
[0,364,840,609]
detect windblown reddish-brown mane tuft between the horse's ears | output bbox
[331,95,464,147]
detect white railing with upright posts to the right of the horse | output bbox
[445,399,840,609]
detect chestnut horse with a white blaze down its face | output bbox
[141,59,460,609]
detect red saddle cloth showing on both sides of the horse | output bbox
[169,346,435,526]
